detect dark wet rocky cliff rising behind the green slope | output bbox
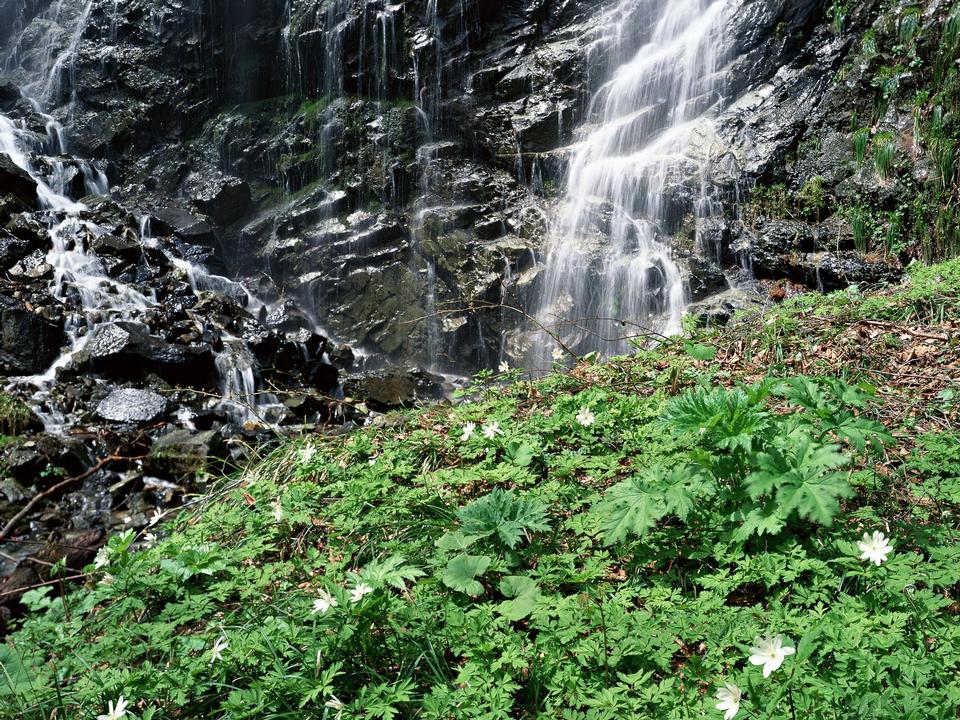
[0,0,960,584]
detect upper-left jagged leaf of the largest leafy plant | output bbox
[662,382,772,452]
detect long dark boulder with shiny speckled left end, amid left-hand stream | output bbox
[76,322,214,388]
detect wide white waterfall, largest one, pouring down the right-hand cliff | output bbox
[528,0,732,367]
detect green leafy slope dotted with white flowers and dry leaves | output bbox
[0,261,960,720]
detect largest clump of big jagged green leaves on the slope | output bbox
[593,377,892,544]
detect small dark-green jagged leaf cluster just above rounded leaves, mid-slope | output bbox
[457,488,550,550]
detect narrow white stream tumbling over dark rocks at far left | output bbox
[0,0,277,431]
